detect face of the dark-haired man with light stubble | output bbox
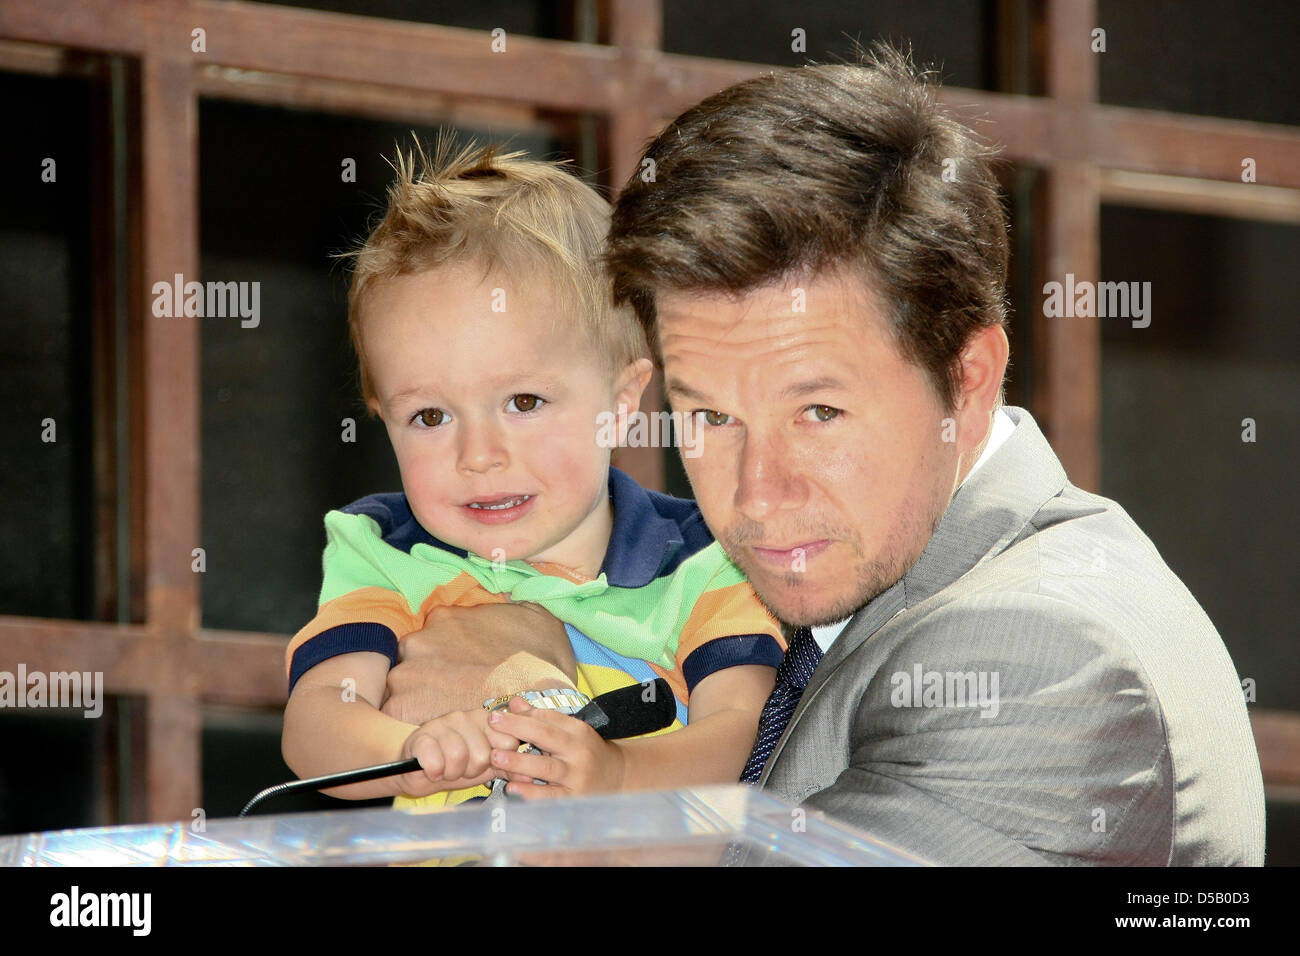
[657,274,959,626]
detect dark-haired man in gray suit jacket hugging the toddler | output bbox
[379,48,1264,865]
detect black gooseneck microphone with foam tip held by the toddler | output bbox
[239,678,677,817]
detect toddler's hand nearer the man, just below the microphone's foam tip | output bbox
[488,697,624,800]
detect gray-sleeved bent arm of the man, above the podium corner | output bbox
[790,606,1173,865]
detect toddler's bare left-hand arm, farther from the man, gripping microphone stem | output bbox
[281,652,519,800]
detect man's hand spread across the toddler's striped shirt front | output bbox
[382,604,577,724]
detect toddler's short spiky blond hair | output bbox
[341,135,646,406]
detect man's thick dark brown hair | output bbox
[607,44,1008,410]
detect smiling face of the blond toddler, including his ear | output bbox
[361,264,650,576]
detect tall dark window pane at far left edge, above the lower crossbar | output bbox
[0,73,103,618]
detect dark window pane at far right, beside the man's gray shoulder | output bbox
[1101,207,1300,709]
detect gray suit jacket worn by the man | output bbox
[763,407,1264,866]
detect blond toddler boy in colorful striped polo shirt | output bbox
[282,144,784,804]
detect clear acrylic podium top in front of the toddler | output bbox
[0,786,923,866]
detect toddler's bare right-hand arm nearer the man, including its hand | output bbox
[489,665,776,797]
